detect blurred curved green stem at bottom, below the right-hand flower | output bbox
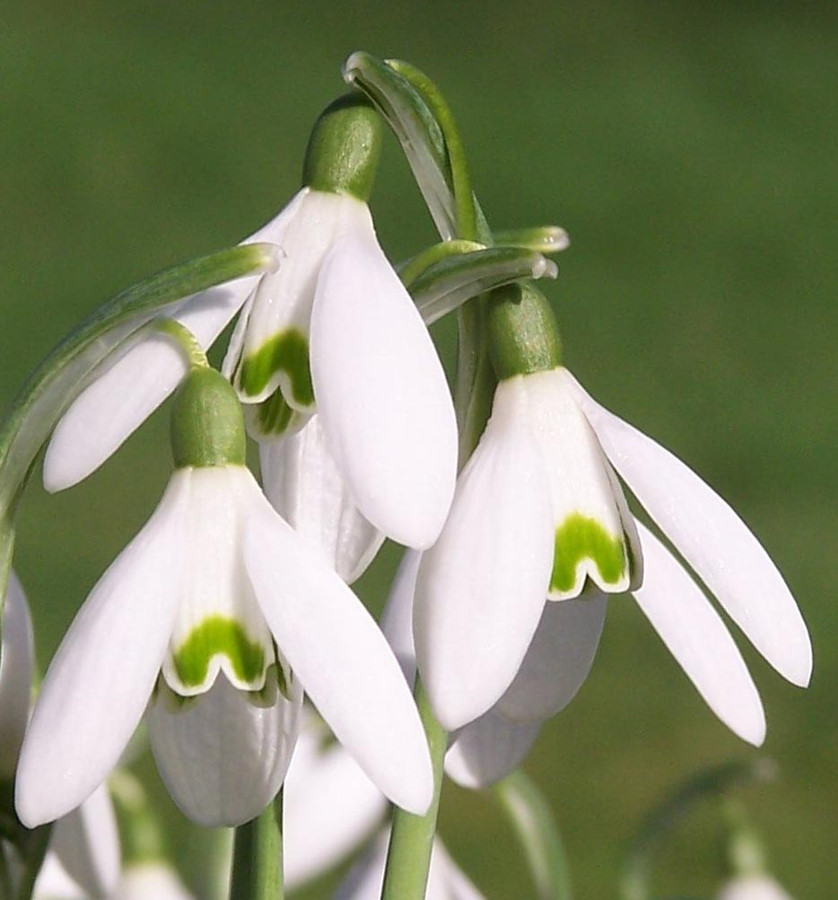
[494,769,573,900]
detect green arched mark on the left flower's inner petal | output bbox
[173,616,265,687]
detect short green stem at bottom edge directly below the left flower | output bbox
[230,791,284,900]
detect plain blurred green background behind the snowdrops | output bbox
[0,0,838,898]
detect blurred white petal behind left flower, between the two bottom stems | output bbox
[282,717,387,890]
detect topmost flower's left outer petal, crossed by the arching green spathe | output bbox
[43,195,301,492]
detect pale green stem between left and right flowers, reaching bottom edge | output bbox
[381,676,448,900]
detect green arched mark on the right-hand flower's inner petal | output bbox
[550,513,627,592]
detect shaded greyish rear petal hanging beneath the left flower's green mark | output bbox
[148,675,302,827]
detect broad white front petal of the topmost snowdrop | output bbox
[311,225,457,549]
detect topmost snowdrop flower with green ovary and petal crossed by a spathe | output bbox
[44,100,457,547]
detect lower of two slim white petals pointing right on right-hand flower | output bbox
[634,522,765,747]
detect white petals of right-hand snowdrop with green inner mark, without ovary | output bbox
[414,367,812,744]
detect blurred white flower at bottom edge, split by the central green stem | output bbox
[335,832,483,900]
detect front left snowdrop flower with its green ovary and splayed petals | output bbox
[16,369,432,827]
